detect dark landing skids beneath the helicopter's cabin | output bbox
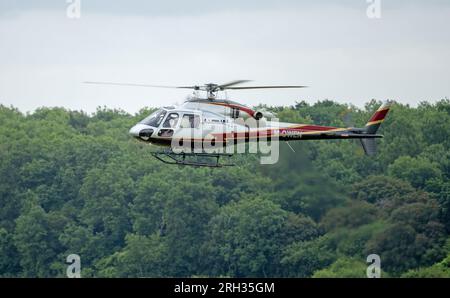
[152,150,234,168]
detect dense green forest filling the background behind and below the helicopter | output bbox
[0,99,450,278]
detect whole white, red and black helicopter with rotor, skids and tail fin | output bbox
[85,80,392,167]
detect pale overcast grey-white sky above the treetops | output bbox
[0,0,450,113]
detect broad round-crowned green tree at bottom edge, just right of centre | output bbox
[206,198,288,277]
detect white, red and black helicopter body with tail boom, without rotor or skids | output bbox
[130,100,381,148]
